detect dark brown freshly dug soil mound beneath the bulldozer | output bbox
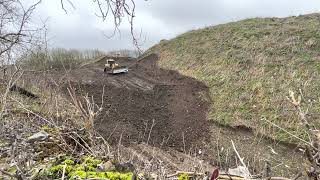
[53,54,209,150]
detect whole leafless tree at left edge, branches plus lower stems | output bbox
[0,0,44,119]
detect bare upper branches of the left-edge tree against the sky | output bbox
[0,0,43,64]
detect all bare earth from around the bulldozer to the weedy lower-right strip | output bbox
[21,54,304,177]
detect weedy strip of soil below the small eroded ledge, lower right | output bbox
[202,123,306,179]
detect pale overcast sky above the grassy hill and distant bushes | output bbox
[25,0,320,51]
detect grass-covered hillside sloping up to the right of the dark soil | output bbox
[146,14,320,141]
